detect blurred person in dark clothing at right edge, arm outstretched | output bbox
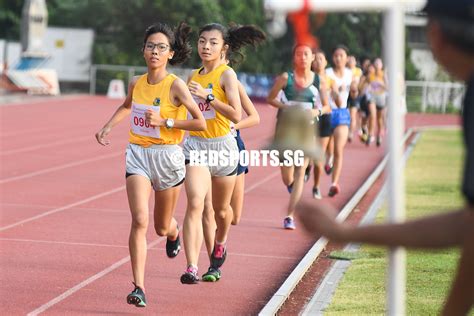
[297,0,474,315]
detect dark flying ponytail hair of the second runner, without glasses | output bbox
[199,23,267,64]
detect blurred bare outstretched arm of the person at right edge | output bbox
[297,203,474,248]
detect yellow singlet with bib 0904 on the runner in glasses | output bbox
[129,74,186,147]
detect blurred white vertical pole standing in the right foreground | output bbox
[384,2,406,316]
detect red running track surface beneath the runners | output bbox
[0,96,459,315]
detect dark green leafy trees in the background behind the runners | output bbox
[0,0,418,74]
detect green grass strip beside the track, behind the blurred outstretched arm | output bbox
[325,131,464,315]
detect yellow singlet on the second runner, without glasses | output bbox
[189,64,231,138]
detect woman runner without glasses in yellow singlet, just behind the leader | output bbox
[181,23,265,284]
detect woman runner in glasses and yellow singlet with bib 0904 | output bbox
[96,23,206,307]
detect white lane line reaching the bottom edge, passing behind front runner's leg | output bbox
[27,237,166,316]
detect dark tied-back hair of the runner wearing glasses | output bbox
[143,22,192,65]
